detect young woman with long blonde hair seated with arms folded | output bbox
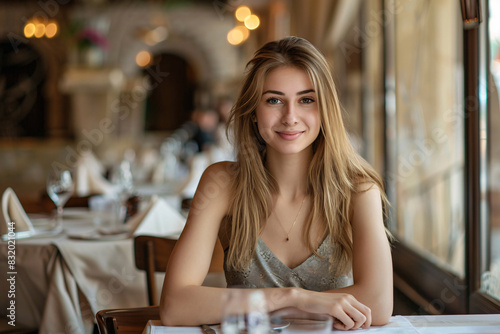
[160,37,393,329]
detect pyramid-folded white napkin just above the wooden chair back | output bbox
[127,196,186,235]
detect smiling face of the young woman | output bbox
[256,66,320,154]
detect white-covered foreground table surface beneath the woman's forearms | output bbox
[143,314,500,334]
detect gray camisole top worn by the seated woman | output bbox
[224,237,352,291]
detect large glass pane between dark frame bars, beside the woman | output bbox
[387,0,465,278]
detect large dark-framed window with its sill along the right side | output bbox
[384,0,500,314]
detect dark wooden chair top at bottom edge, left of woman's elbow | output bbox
[96,306,160,334]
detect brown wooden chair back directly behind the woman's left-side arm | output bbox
[134,235,224,306]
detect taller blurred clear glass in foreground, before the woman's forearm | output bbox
[221,289,271,334]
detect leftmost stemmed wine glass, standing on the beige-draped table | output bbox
[47,169,75,230]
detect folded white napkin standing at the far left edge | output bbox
[0,188,35,234]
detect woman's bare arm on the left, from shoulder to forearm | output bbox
[160,163,231,325]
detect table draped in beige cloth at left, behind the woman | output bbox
[0,209,225,334]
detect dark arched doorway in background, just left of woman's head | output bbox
[144,53,197,132]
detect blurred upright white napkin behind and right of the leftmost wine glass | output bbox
[75,152,115,196]
